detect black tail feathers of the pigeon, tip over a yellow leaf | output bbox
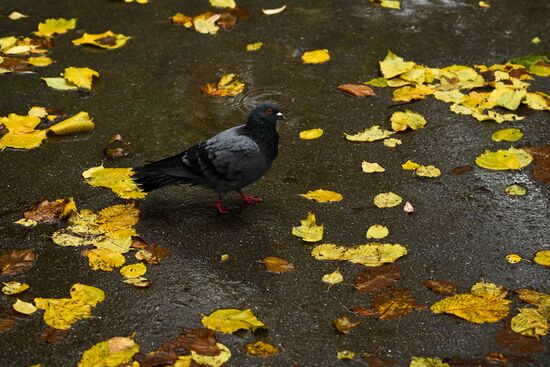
[132,155,187,192]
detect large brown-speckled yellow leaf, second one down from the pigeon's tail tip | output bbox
[52,204,139,253]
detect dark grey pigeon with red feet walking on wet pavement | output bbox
[132,103,285,214]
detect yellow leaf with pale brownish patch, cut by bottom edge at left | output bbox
[77,336,139,367]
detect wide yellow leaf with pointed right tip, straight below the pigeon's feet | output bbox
[201,308,267,333]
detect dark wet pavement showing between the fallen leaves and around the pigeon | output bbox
[0,0,550,366]
